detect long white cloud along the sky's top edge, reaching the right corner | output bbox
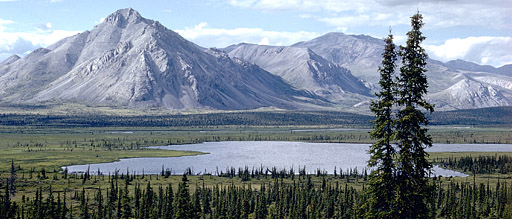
[229,0,512,29]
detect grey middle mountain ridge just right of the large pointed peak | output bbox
[224,43,370,106]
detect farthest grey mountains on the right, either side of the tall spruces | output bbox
[292,33,512,110]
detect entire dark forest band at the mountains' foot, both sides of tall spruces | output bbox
[0,106,512,128]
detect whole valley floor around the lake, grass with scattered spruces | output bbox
[0,111,512,218]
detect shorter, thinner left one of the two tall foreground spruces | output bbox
[364,30,397,218]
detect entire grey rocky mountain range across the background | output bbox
[0,9,512,110]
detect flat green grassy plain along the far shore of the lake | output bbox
[0,126,512,172]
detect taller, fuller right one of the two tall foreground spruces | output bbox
[394,12,434,218]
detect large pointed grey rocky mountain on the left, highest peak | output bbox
[0,9,325,110]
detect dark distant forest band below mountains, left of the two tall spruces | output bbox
[0,111,371,127]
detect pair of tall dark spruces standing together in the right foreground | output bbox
[364,12,434,218]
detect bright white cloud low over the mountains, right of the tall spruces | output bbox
[425,36,512,67]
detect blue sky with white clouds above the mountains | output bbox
[0,0,512,67]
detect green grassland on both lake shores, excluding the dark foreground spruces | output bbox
[0,122,512,216]
